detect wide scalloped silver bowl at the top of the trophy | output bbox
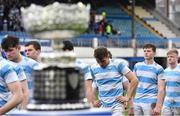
[21,2,90,39]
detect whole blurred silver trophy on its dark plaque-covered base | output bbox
[21,2,90,110]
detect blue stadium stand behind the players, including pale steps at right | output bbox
[0,0,179,54]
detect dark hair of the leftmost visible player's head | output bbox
[1,35,19,51]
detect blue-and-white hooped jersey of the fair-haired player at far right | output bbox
[163,65,180,108]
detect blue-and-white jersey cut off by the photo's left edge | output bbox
[0,58,19,107]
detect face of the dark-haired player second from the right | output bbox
[143,48,155,60]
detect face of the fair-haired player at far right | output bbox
[167,53,178,65]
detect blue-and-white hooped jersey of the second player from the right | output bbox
[133,61,164,103]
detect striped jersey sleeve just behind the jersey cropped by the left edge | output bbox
[9,61,26,81]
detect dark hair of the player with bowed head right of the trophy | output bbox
[94,47,109,60]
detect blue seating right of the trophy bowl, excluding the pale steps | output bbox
[72,6,168,48]
